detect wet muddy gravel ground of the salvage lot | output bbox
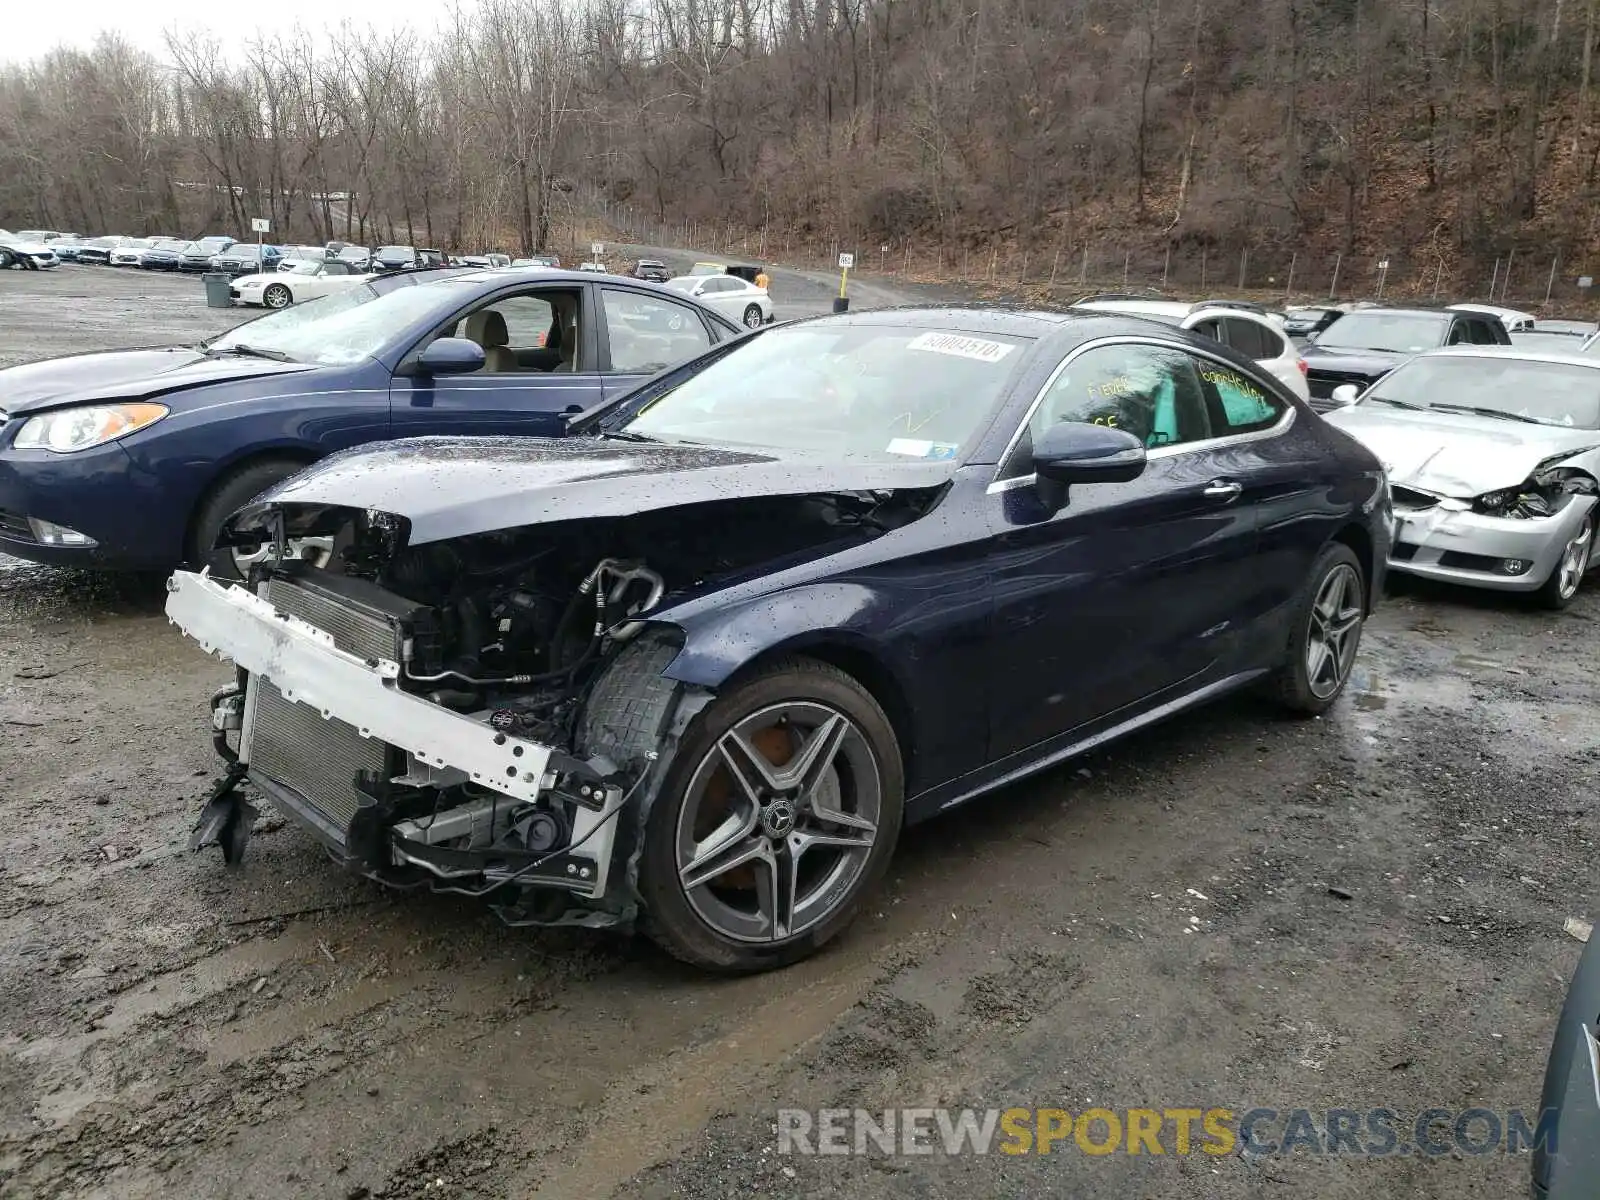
[0,267,1600,1200]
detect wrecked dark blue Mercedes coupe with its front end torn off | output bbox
[166,309,1390,971]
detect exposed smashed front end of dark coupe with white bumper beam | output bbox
[166,441,933,926]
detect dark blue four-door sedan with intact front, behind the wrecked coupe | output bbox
[0,268,741,574]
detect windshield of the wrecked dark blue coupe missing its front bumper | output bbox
[611,325,1027,459]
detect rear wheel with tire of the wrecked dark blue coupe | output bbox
[1270,542,1366,717]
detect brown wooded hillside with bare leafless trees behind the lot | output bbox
[0,0,1600,294]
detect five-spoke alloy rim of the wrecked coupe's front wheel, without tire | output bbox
[677,701,883,942]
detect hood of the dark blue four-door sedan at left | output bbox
[0,346,315,416]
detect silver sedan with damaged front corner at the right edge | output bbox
[1326,347,1600,608]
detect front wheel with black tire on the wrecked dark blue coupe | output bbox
[586,646,906,973]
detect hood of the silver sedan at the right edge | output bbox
[1323,403,1600,499]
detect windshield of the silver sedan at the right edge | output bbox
[1358,354,1600,429]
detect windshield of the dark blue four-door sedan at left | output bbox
[206,283,451,366]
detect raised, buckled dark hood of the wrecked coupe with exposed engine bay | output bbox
[230,437,952,546]
